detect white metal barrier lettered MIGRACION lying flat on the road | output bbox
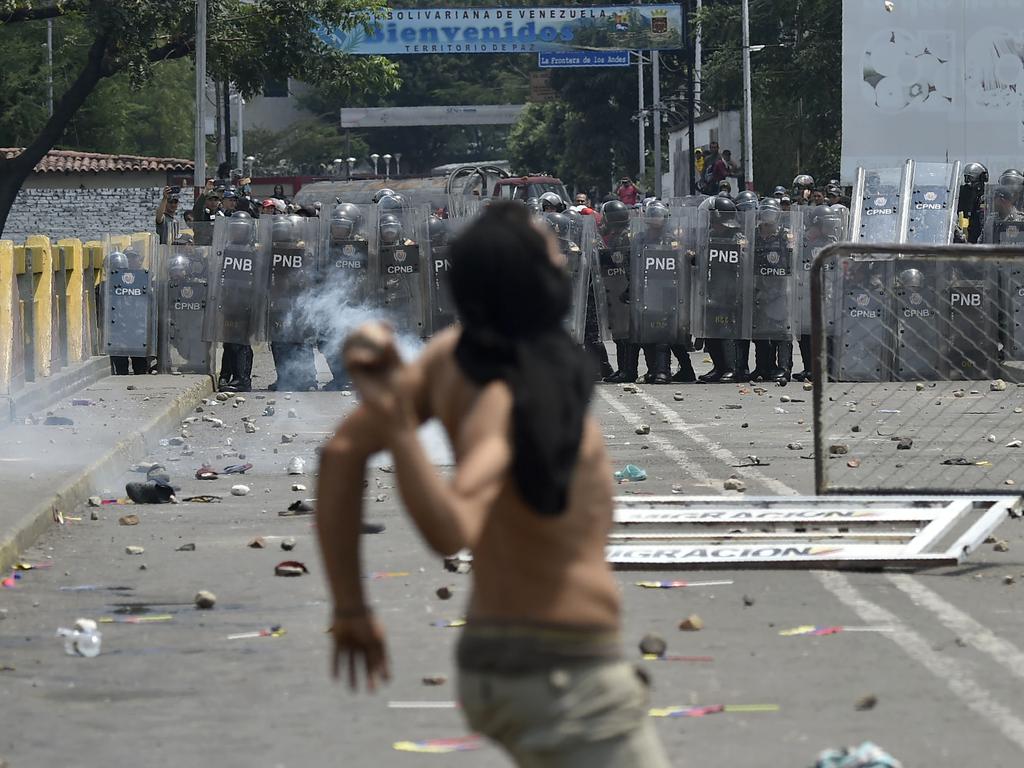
[606,495,1024,570]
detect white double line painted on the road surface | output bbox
[601,391,1024,749]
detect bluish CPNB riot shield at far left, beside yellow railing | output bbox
[102,238,158,357]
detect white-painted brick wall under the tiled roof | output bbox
[3,186,163,242]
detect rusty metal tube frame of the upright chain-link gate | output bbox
[811,243,1024,497]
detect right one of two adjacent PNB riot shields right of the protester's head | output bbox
[692,209,757,340]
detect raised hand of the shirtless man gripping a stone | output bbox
[342,323,416,431]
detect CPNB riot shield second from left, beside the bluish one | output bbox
[157,238,214,374]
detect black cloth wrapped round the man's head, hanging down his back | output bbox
[449,202,594,515]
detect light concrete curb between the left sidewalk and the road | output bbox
[0,376,213,570]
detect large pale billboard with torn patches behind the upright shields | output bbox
[842,0,1024,183]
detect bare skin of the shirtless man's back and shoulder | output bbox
[424,330,620,628]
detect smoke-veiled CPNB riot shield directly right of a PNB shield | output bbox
[308,203,378,337]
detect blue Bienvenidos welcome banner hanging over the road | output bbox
[319,5,683,55]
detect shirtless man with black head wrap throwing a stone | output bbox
[316,203,669,768]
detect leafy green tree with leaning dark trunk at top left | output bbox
[0,0,397,232]
